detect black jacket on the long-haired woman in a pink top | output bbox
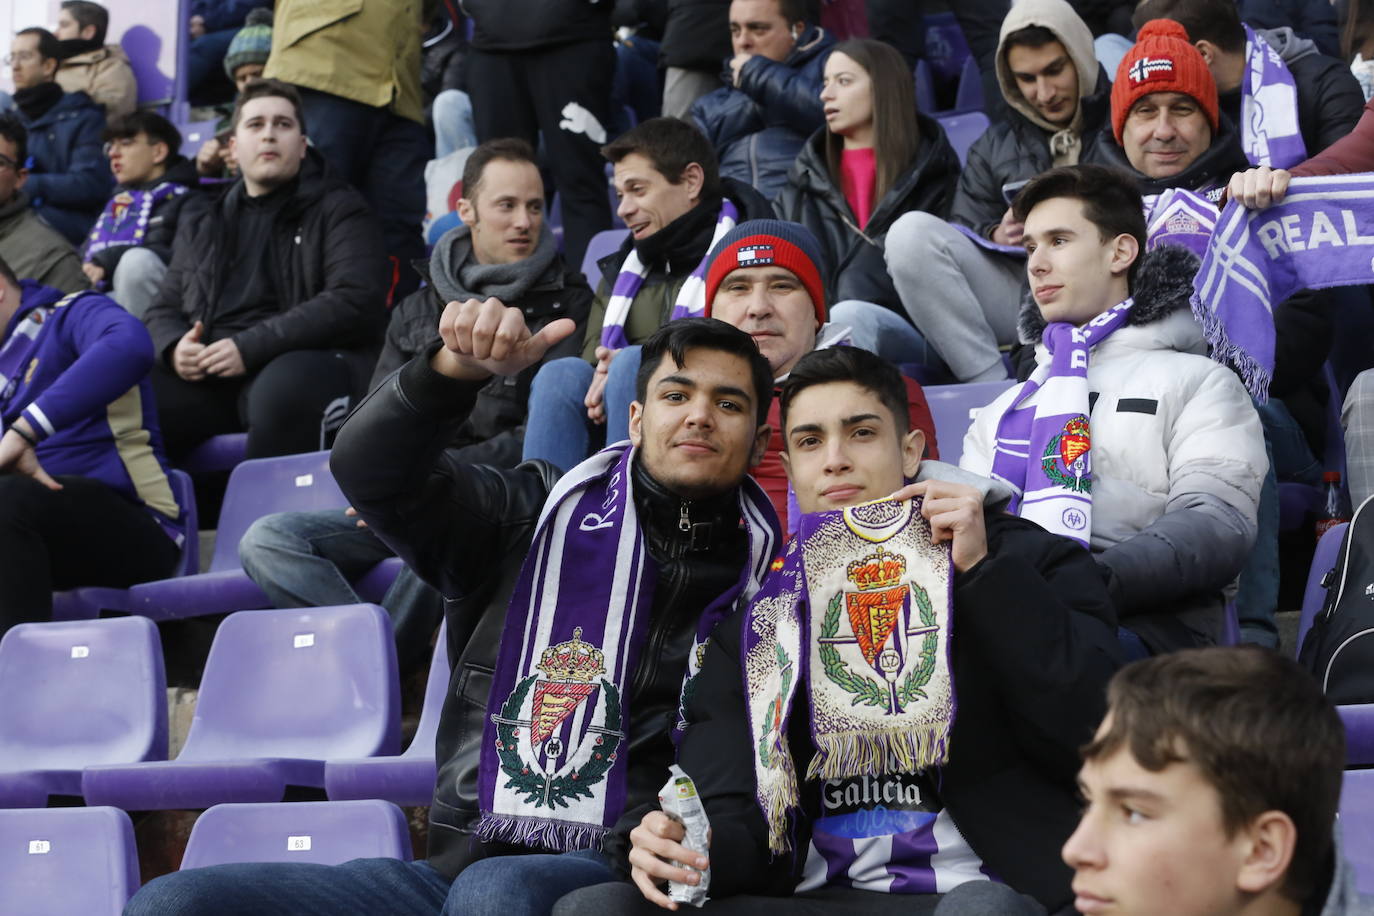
[776,114,959,314]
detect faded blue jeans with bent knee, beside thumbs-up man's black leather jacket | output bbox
[239,509,444,673]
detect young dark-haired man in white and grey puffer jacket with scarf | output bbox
[960,166,1268,655]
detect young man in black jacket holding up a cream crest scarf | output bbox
[554,347,1121,916]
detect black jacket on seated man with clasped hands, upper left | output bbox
[143,150,387,372]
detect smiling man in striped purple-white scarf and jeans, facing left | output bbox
[525,118,774,470]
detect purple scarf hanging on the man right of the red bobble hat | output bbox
[1241,26,1307,169]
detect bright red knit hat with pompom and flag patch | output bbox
[1112,19,1219,143]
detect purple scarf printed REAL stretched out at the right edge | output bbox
[1191,174,1374,401]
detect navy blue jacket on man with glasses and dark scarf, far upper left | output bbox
[21,92,114,244]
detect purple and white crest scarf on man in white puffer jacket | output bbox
[991,299,1135,547]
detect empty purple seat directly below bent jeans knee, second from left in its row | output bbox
[81,604,401,810]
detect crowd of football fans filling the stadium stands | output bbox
[0,0,1374,916]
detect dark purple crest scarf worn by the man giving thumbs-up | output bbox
[478,442,780,850]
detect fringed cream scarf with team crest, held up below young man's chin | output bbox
[741,499,955,854]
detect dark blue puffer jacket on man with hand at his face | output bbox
[691,26,835,201]
